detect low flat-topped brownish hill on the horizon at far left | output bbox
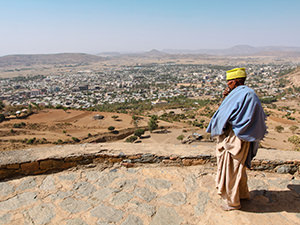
[0,53,103,67]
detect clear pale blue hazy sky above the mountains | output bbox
[0,0,300,55]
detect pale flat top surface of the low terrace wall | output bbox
[0,142,300,166]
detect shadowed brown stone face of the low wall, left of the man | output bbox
[0,152,215,180]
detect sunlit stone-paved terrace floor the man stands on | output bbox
[0,164,300,225]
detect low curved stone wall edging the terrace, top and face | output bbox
[0,144,300,180]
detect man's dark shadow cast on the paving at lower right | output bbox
[241,184,300,213]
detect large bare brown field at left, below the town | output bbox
[0,109,182,150]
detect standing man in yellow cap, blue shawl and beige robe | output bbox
[206,68,266,211]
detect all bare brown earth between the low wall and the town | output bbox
[0,100,300,150]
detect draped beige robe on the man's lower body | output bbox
[216,128,250,208]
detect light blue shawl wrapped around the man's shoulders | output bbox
[206,85,267,168]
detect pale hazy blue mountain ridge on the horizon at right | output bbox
[163,45,300,56]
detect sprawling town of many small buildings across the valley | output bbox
[0,63,296,108]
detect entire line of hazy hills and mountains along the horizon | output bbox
[0,45,300,67]
